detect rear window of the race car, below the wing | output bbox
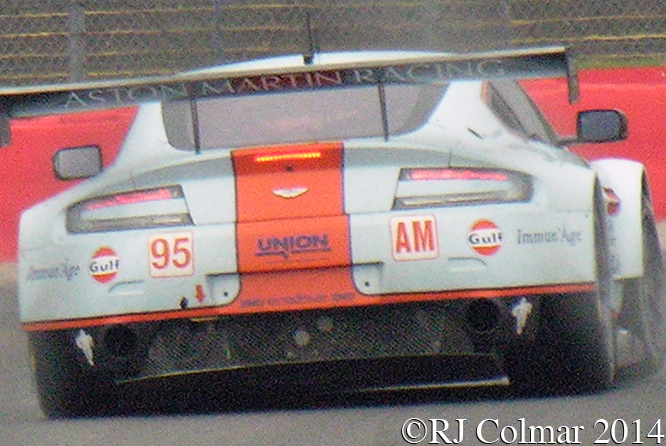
[163,84,446,150]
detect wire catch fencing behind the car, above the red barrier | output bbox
[0,0,666,86]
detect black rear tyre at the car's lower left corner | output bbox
[29,332,118,418]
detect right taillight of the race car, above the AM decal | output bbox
[393,168,532,209]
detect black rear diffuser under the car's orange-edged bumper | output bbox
[31,296,545,392]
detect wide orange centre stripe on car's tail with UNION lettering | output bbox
[232,142,351,276]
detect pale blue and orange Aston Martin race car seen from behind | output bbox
[6,47,665,417]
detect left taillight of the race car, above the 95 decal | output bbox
[67,186,192,233]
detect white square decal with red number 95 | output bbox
[148,232,194,277]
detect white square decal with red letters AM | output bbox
[391,215,439,261]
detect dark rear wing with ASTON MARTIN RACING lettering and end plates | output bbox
[0,47,578,146]
